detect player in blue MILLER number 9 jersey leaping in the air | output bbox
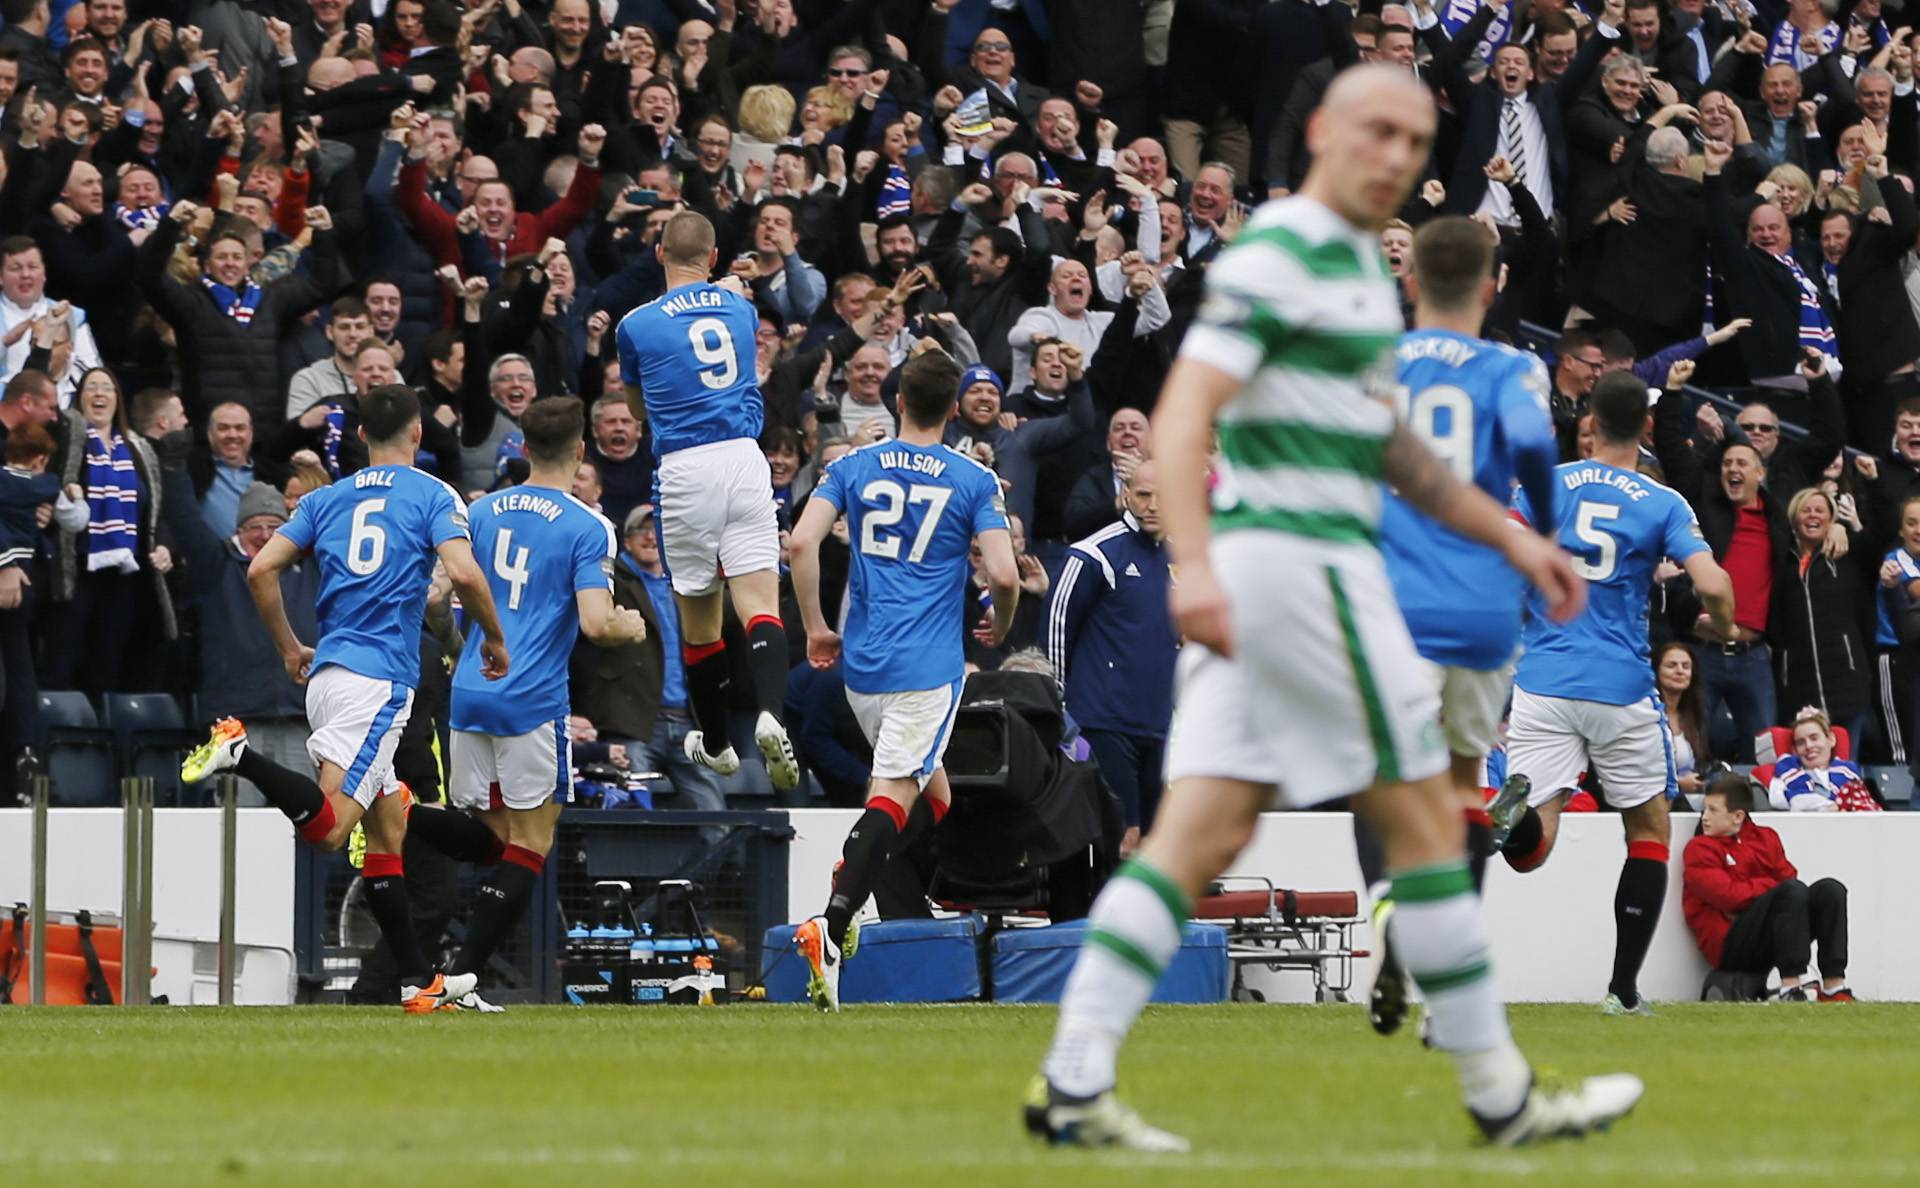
[618,211,801,789]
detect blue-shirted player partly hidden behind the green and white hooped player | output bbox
[1354,217,1559,1034]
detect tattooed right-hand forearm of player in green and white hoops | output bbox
[1382,424,1586,624]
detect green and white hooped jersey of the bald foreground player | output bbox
[1181,198,1405,543]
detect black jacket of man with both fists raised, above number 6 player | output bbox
[140,219,340,432]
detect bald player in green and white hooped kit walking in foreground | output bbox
[1025,65,1642,1152]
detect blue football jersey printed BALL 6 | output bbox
[280,466,467,689]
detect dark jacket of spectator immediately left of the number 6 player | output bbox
[161,454,321,722]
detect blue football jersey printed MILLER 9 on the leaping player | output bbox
[614,284,766,457]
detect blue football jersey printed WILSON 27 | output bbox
[812,441,1006,693]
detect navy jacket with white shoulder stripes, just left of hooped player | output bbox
[1046,512,1181,739]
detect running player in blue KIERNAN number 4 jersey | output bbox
[413,395,647,1011]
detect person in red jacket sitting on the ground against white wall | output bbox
[1680,775,1853,1002]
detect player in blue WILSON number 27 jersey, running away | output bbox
[791,351,1020,1011]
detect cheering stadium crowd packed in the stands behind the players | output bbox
[0,0,1920,825]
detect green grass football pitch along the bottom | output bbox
[0,1004,1920,1188]
